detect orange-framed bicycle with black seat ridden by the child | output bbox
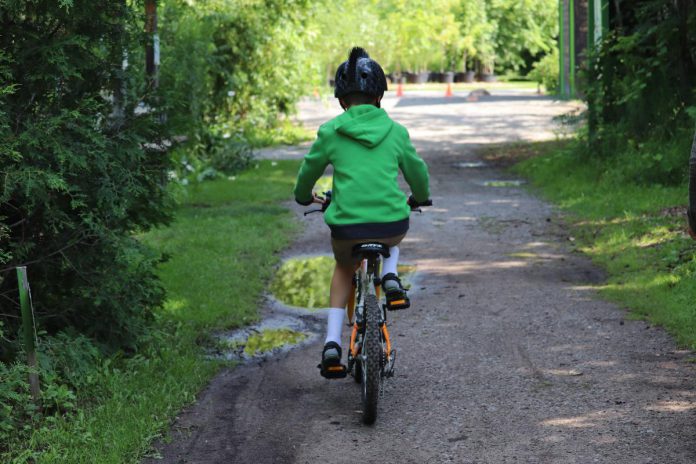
[305,190,432,424]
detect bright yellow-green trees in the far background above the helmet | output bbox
[306,0,558,81]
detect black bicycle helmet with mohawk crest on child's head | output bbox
[334,47,387,98]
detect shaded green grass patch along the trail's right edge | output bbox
[513,142,696,349]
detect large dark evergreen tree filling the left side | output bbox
[0,1,169,360]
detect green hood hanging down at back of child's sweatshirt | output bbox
[334,105,394,148]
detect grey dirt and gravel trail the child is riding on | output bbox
[144,89,696,464]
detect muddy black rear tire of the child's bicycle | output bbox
[362,295,383,424]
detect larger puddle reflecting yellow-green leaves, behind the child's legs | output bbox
[271,256,416,309]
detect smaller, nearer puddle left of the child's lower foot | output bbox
[211,316,311,361]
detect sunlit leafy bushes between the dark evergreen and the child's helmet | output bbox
[159,0,308,169]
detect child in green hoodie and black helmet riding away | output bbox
[294,47,430,375]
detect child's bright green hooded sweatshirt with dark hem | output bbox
[295,105,430,238]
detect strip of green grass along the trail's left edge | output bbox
[5,161,298,464]
